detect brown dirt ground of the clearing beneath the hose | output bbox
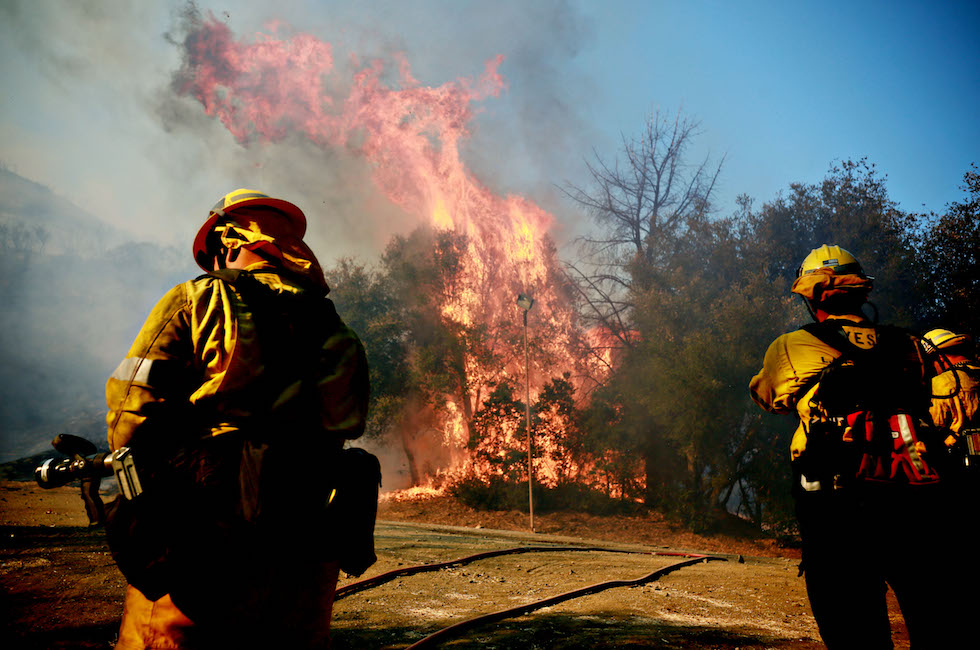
[0,481,908,650]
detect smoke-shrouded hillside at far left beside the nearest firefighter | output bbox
[0,169,191,462]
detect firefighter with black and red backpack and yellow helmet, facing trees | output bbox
[749,244,955,648]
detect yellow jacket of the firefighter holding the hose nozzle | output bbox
[106,264,369,449]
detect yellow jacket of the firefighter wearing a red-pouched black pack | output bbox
[749,316,904,459]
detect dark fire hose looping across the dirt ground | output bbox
[334,546,725,650]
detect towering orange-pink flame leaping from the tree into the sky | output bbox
[179,15,604,482]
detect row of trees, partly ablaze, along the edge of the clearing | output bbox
[328,107,980,528]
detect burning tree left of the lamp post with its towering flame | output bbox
[174,11,608,482]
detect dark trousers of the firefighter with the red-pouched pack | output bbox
[796,486,965,650]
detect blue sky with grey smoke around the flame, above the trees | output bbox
[0,0,980,260]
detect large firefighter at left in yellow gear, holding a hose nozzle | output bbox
[106,189,369,650]
